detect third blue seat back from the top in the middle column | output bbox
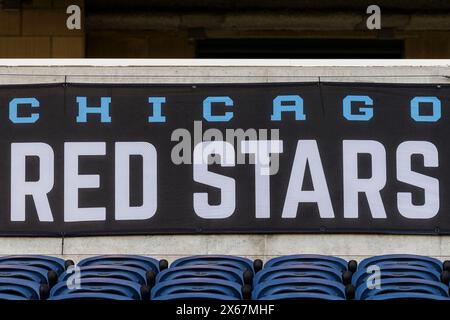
[151,278,243,299]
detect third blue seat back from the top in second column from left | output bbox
[50,278,145,300]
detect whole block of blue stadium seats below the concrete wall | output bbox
[0,254,450,300]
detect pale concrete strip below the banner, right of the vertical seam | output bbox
[59,234,450,261]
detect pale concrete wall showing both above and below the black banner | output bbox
[0,60,450,261]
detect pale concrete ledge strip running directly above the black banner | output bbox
[0,60,450,84]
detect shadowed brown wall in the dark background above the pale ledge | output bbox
[0,0,450,59]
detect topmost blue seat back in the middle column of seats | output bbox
[170,255,254,272]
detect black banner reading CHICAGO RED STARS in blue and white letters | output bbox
[0,83,450,236]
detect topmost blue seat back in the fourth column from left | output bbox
[264,254,348,271]
